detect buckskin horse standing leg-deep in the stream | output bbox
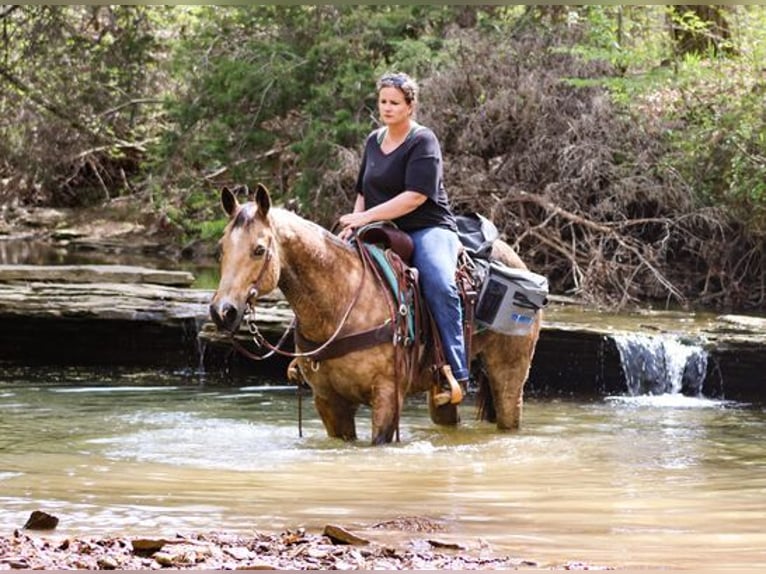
[210,184,541,444]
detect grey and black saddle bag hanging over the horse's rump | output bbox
[475,261,548,335]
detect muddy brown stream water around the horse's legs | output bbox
[0,369,766,568]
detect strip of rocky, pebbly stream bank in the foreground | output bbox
[0,519,611,570]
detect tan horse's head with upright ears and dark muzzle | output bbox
[210,184,279,333]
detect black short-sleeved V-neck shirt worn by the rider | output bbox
[356,124,457,231]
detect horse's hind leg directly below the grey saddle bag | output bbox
[481,335,536,430]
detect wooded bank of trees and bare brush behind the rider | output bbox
[0,5,766,311]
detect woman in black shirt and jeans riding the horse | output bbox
[340,73,469,404]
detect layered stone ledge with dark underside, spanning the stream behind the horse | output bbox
[0,265,766,402]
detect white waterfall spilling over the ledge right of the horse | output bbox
[613,333,708,396]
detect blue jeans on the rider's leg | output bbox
[408,227,468,380]
